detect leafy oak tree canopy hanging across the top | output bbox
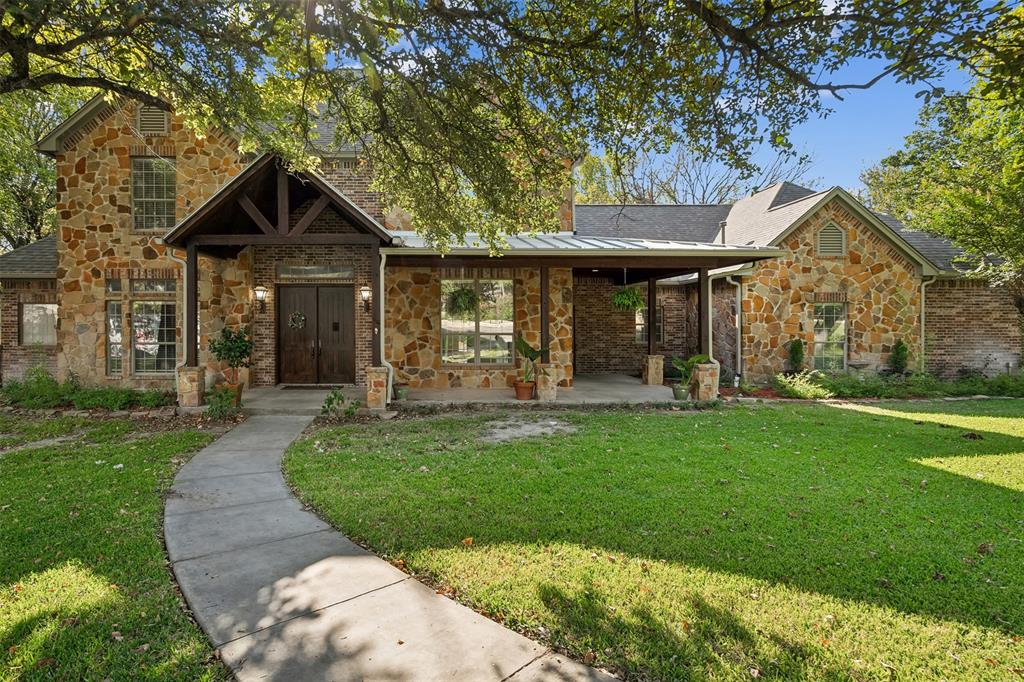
[0,0,1021,243]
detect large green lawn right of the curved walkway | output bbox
[286,400,1024,680]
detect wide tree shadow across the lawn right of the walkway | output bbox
[311,407,1024,633]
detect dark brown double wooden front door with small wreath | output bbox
[278,285,355,384]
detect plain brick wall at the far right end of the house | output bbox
[925,280,1024,378]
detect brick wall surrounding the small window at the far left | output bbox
[0,280,57,383]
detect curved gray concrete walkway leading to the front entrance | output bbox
[164,416,612,682]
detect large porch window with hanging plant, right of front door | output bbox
[441,280,514,365]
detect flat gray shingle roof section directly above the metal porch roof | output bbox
[575,204,730,242]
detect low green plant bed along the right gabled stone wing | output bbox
[774,371,1024,399]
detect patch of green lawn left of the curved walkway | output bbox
[0,416,227,680]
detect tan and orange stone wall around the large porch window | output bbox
[384,267,574,388]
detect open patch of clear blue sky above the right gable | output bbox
[793,62,967,188]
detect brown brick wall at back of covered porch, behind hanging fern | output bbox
[573,275,697,376]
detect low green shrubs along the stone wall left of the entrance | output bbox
[0,366,174,412]
